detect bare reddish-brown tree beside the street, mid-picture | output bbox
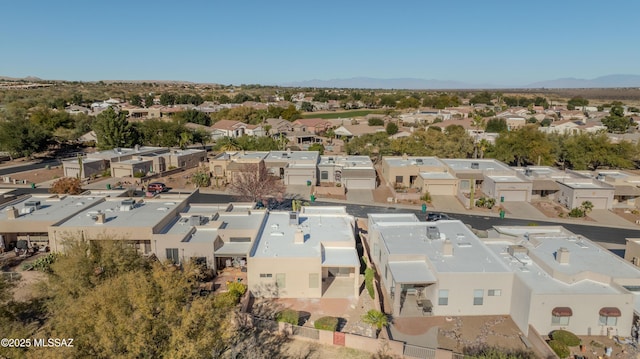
[229,163,286,202]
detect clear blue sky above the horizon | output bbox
[0,0,640,85]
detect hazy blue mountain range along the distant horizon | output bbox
[0,74,640,90]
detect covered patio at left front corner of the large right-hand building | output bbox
[389,261,436,317]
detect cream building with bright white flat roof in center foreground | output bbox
[247,207,360,299]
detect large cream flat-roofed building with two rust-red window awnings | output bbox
[366,214,640,336]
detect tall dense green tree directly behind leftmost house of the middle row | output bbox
[92,108,137,150]
